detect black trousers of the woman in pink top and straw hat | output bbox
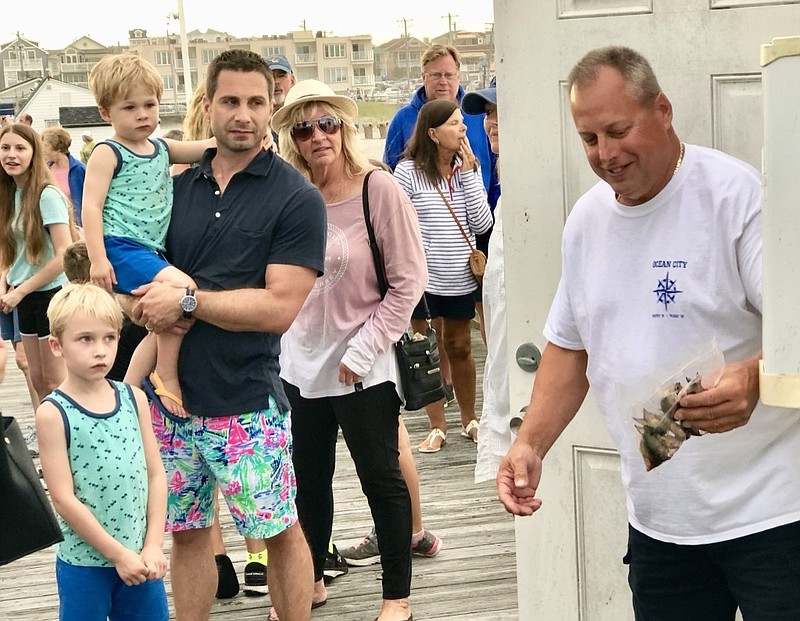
[284,382,411,599]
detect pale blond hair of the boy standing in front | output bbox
[47,283,122,338]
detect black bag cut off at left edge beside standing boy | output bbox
[0,416,64,565]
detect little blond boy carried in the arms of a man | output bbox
[83,54,215,417]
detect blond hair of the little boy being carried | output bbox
[89,53,164,110]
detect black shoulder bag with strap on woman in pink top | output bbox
[361,171,444,412]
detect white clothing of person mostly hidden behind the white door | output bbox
[475,197,513,483]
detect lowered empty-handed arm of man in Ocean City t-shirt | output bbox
[497,343,589,516]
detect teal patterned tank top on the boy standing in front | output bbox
[46,381,147,567]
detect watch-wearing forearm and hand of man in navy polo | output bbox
[132,264,317,334]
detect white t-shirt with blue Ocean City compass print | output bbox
[544,145,800,544]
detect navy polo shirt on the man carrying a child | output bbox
[166,149,327,416]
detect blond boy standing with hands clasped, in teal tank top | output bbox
[36,284,169,621]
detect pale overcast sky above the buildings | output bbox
[14,0,494,49]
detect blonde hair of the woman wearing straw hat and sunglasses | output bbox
[280,101,374,179]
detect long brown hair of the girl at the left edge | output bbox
[0,123,66,270]
